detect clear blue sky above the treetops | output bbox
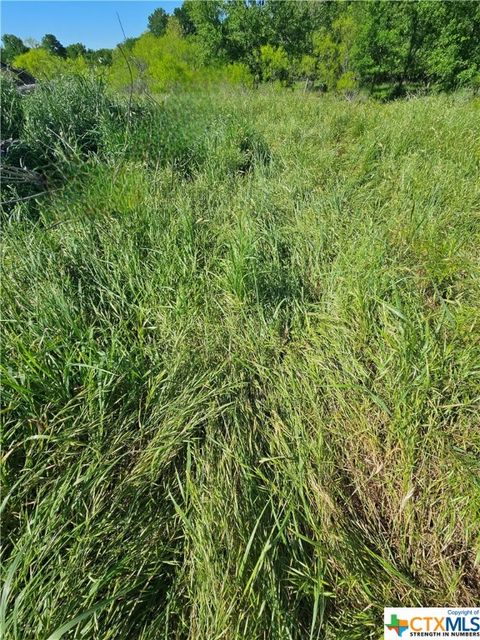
[1,0,182,49]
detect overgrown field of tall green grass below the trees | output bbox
[0,81,480,640]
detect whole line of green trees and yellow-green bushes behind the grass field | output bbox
[2,0,480,96]
